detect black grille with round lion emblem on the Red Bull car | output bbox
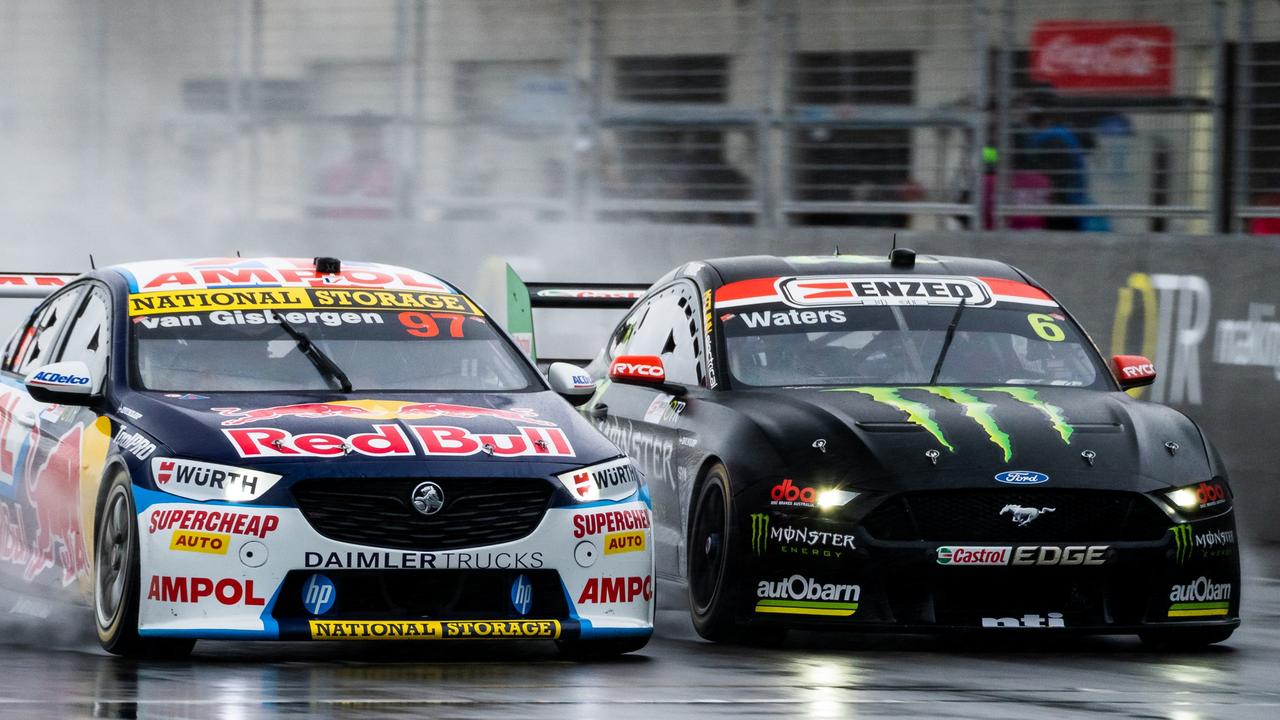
[293,478,553,550]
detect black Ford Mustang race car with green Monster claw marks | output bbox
[512,249,1240,646]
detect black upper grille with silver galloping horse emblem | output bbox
[863,489,1170,542]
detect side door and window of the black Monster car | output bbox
[588,281,704,575]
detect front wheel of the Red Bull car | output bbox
[93,471,196,659]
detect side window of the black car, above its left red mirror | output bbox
[622,283,703,384]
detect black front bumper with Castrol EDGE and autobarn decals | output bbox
[740,502,1240,634]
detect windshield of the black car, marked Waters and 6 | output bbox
[718,283,1105,387]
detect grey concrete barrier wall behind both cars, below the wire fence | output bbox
[0,222,1280,541]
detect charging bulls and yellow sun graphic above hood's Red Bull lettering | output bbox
[214,400,554,427]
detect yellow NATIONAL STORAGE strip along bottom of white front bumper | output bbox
[310,620,561,641]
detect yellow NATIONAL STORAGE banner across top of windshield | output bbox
[129,287,480,316]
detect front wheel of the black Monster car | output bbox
[689,462,786,646]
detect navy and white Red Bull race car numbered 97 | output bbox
[0,258,653,655]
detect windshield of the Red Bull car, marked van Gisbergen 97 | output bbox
[131,293,538,392]
